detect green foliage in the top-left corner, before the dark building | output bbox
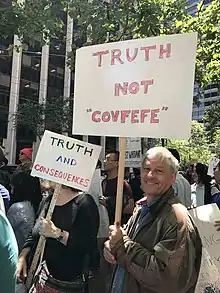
[0,0,63,45]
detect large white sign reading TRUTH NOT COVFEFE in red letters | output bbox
[73,33,197,139]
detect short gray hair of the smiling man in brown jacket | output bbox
[142,147,179,174]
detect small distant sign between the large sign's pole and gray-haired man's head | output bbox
[125,137,142,168]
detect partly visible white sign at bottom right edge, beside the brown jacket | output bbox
[190,204,220,293]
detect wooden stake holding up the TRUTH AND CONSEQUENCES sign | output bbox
[26,184,61,289]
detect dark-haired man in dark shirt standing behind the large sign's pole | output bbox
[100,150,134,224]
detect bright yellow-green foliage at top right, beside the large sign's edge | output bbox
[180,0,220,87]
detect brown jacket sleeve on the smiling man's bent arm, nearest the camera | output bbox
[111,217,199,293]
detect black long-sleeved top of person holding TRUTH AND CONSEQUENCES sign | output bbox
[24,194,99,281]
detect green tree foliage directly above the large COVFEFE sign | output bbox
[66,0,188,69]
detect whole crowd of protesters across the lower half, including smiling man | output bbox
[0,147,220,293]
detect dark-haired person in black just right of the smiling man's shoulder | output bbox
[191,163,212,206]
